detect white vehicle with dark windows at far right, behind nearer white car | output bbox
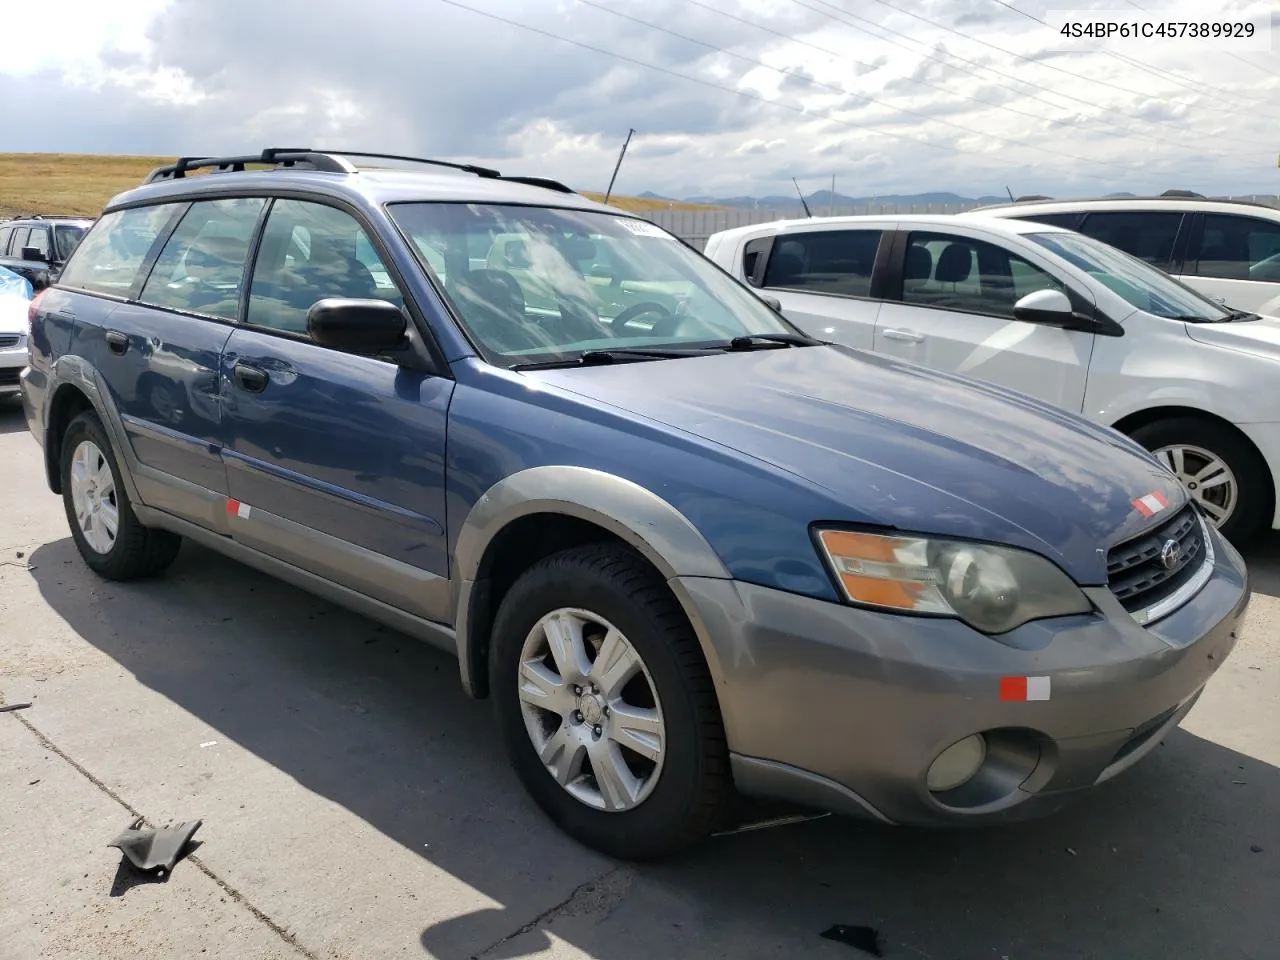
[966,191,1280,316]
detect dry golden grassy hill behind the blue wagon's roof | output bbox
[0,154,716,216]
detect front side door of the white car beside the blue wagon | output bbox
[876,230,1094,412]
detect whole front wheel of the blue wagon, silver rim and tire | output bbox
[490,545,732,860]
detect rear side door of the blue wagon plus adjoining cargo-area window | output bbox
[61,198,266,529]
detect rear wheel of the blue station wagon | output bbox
[60,411,182,580]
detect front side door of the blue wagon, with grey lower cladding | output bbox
[221,200,453,622]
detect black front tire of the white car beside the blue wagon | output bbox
[1130,417,1275,547]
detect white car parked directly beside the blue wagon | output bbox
[705,215,1280,543]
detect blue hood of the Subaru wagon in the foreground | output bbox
[531,346,1187,584]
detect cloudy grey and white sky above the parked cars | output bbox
[0,0,1280,196]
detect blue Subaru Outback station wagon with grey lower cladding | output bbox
[22,150,1249,859]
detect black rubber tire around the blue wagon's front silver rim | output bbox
[490,544,733,861]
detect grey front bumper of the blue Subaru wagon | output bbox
[672,522,1249,826]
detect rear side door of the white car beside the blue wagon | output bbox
[742,225,892,349]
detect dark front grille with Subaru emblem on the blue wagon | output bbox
[1107,504,1208,621]
